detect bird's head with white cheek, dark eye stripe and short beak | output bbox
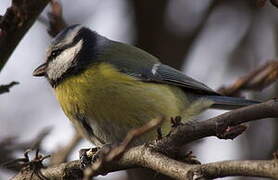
[33,25,109,87]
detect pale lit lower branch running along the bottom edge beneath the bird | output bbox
[12,145,278,180]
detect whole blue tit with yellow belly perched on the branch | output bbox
[33,25,257,146]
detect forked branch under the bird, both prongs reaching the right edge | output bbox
[10,99,278,179]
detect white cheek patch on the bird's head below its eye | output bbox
[47,40,83,80]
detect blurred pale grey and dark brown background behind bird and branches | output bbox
[0,0,278,179]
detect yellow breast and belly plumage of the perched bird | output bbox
[55,64,188,143]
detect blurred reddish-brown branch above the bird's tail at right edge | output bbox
[219,61,278,96]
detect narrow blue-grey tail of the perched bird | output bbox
[206,95,260,110]
